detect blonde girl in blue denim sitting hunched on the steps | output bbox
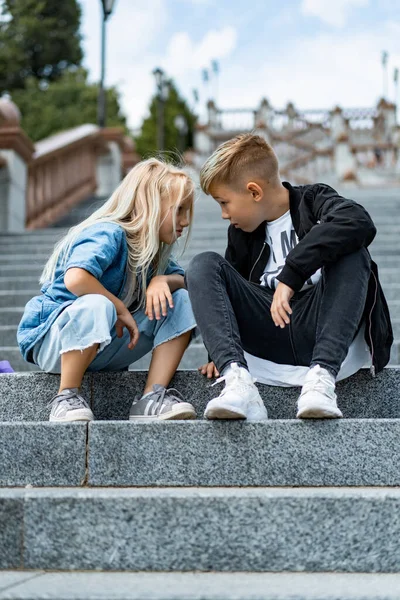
[17,158,196,421]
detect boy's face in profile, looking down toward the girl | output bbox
[210,183,265,233]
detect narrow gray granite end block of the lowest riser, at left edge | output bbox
[0,490,23,569]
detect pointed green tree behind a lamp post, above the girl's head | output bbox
[135,80,197,157]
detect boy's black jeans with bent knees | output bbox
[186,248,371,376]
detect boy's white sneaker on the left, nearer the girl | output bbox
[204,363,268,421]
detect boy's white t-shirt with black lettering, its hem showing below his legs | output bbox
[244,211,372,387]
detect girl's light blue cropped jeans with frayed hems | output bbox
[33,289,196,373]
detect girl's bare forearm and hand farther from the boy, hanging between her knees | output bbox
[64,267,139,349]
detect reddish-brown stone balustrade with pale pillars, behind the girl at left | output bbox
[0,98,139,232]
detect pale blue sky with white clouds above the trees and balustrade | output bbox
[80,0,400,130]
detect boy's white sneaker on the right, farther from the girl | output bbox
[296,365,343,419]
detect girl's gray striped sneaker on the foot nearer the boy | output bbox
[129,384,196,421]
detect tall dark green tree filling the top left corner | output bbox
[0,0,83,93]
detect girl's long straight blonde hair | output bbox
[40,158,194,305]
